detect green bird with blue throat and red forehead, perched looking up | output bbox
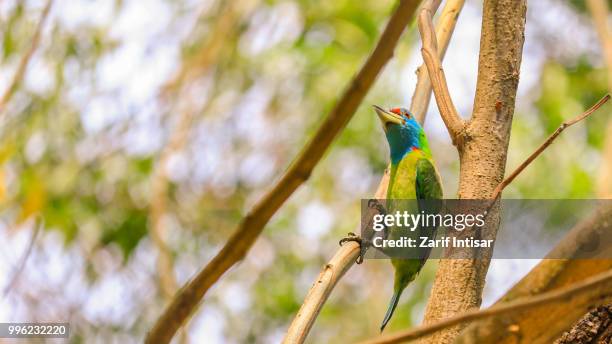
[374,106,442,332]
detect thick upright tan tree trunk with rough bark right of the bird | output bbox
[424,0,527,343]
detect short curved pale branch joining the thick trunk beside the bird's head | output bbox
[418,0,465,146]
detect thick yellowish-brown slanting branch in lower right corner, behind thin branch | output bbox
[455,201,612,344]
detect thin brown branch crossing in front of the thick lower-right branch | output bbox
[363,271,612,344]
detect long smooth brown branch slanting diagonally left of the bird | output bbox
[145,1,426,343]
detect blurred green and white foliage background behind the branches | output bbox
[0,0,609,343]
